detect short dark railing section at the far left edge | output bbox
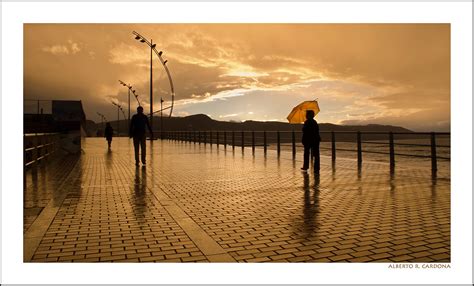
[23,133,59,167]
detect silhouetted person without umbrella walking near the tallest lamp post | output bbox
[129,106,153,166]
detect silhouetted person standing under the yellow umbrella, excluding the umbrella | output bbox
[301,110,321,174]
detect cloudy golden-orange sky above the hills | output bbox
[24,24,450,131]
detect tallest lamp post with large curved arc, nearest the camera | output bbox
[133,31,174,140]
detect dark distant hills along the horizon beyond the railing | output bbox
[86,114,413,139]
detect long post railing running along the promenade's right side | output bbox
[161,130,450,173]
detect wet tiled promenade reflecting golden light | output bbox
[24,138,450,262]
